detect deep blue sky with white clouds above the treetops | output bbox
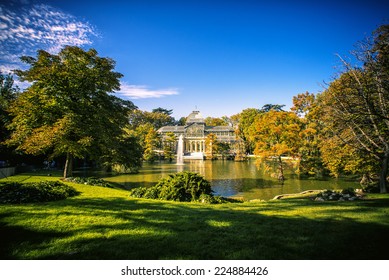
[0,0,389,118]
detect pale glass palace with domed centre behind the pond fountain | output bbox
[158,111,236,159]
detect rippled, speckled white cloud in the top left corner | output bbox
[0,1,99,65]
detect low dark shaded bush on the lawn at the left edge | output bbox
[0,181,79,204]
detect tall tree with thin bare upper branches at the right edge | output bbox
[323,25,389,193]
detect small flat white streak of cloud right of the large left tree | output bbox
[116,82,178,99]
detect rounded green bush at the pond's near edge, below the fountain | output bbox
[130,171,213,201]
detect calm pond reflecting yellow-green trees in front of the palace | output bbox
[104,160,360,200]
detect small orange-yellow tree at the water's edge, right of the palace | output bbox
[251,110,300,180]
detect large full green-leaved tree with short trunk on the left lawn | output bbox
[7,46,136,177]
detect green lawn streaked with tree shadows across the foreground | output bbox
[0,171,389,259]
